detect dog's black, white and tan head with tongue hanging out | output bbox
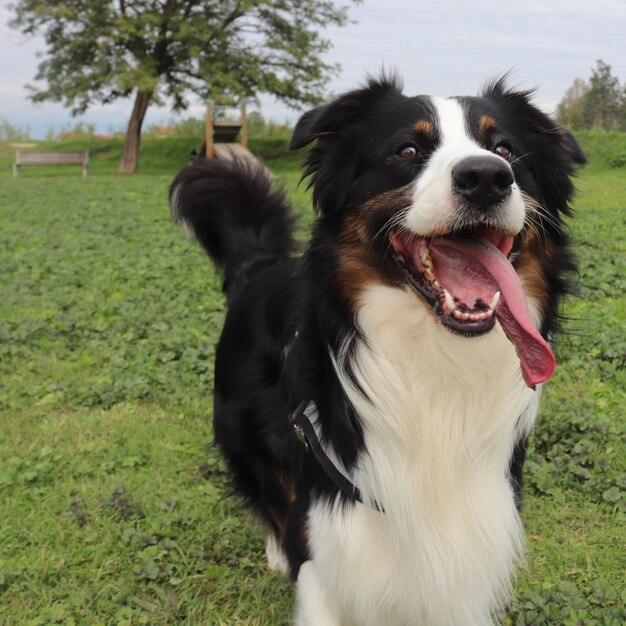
[290,77,585,385]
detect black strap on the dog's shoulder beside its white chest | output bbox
[289,400,385,513]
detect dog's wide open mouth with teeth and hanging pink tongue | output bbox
[389,229,555,387]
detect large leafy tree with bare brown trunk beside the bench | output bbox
[11,0,360,172]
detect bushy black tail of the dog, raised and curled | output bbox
[170,159,295,292]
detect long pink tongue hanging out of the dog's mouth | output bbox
[428,238,555,387]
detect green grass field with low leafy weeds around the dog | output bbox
[0,133,626,626]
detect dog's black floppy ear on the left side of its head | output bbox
[289,74,402,213]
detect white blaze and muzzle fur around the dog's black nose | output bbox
[404,98,525,236]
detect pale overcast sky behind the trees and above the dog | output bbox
[0,0,626,137]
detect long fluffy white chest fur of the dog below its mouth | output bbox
[298,286,539,626]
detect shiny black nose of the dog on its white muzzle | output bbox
[452,156,515,209]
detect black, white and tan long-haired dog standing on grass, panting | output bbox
[170,75,585,626]
